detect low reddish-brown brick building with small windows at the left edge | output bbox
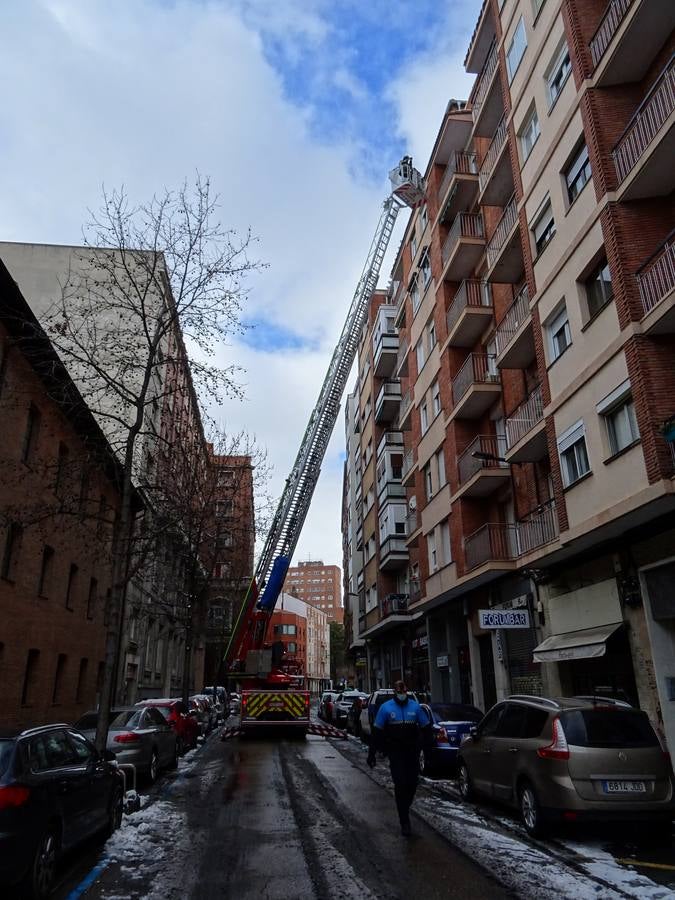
[0,262,120,727]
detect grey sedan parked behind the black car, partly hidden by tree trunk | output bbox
[74,706,178,782]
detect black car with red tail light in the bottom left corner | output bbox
[0,725,124,900]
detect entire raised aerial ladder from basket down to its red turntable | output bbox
[224,156,424,732]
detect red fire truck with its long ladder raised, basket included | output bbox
[224,156,424,734]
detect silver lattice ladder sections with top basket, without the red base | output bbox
[225,157,424,660]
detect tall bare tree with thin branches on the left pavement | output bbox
[37,176,261,749]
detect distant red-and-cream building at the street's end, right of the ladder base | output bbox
[265,593,330,694]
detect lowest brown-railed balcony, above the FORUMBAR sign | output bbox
[464,502,558,571]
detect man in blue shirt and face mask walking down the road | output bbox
[368,681,431,837]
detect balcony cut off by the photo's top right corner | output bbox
[589,0,675,87]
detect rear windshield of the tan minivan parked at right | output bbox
[560,709,659,748]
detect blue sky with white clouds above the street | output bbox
[0,0,480,566]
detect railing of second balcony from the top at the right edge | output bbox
[612,56,675,183]
